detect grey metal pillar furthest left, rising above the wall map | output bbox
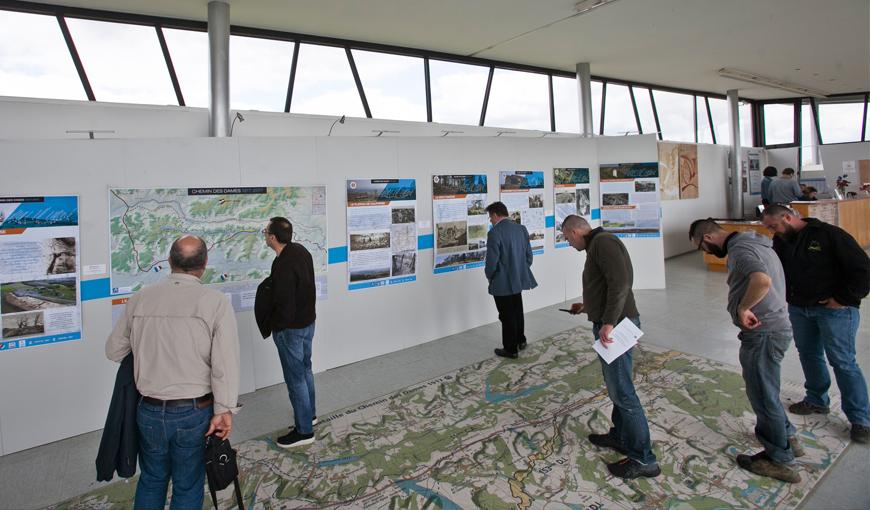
[208,0,230,137]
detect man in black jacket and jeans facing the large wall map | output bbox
[263,216,317,448]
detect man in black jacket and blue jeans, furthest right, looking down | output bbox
[761,205,870,444]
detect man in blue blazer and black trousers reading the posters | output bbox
[484,202,538,359]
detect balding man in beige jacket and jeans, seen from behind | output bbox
[106,236,239,509]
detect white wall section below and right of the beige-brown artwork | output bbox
[662,144,728,258]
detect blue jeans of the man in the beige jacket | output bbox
[133,400,212,510]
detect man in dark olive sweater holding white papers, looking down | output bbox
[562,214,661,479]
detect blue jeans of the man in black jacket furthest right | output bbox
[788,305,870,426]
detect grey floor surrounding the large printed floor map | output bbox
[0,253,870,510]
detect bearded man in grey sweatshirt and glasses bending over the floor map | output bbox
[689,218,804,483]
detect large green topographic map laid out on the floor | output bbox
[56,328,848,510]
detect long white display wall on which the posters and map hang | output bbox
[0,137,664,454]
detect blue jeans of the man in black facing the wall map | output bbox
[272,322,317,435]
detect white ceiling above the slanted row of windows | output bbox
[27,0,870,99]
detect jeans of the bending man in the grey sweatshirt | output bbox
[738,331,797,464]
